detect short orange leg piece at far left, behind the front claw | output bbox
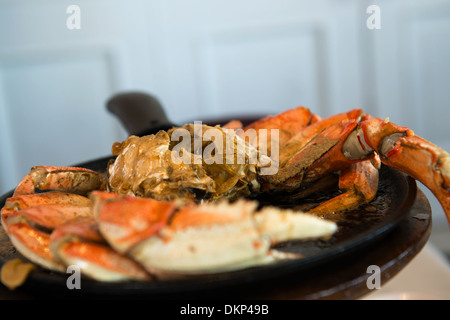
[14,166,105,196]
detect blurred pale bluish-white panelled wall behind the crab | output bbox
[0,0,450,254]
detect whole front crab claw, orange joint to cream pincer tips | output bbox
[91,192,336,278]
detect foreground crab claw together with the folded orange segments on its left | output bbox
[2,190,337,281]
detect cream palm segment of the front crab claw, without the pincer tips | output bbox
[131,201,270,274]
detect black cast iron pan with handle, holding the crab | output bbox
[0,93,417,299]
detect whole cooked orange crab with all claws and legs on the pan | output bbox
[1,107,450,281]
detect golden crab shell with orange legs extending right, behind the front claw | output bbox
[108,107,450,219]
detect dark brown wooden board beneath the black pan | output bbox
[0,190,431,300]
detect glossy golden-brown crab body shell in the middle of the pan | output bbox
[108,124,269,202]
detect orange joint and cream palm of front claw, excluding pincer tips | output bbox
[91,192,269,275]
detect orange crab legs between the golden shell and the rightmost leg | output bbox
[256,109,380,214]
